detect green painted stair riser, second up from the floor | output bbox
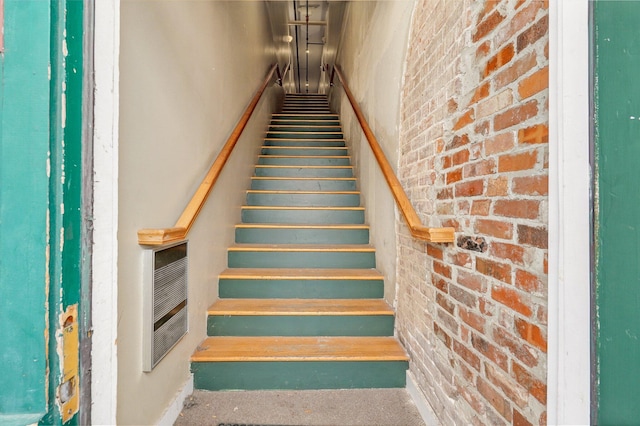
[207,315,393,336]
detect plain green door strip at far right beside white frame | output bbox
[584,1,640,425]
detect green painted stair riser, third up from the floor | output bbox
[218,278,384,299]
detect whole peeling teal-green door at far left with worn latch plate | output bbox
[0,0,90,425]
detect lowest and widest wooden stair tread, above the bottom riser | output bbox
[191,336,409,362]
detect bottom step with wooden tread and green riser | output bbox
[191,337,409,390]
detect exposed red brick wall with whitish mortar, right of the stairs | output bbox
[397,0,548,425]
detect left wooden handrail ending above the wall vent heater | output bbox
[138,64,277,246]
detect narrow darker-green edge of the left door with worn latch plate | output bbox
[41,0,91,424]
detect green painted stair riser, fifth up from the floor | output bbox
[236,228,369,244]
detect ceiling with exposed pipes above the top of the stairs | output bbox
[266,0,347,93]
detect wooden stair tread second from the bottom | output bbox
[207,299,394,316]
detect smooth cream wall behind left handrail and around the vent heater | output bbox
[114,0,281,424]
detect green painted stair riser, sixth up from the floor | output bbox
[241,208,364,224]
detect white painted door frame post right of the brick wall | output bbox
[547,0,592,424]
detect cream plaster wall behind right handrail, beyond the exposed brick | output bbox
[331,0,414,302]
